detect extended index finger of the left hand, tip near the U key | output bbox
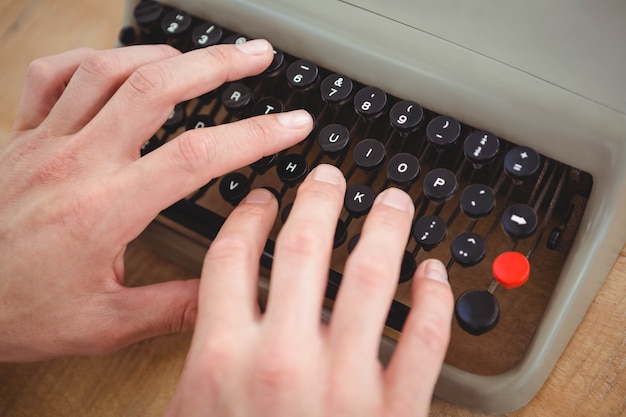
[109,110,313,240]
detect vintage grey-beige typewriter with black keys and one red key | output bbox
[120,0,626,413]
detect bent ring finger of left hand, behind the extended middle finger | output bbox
[41,45,180,135]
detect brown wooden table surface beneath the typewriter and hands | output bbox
[0,0,626,417]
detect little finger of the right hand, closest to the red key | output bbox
[385,259,454,415]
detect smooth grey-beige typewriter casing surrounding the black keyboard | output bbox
[120,0,626,413]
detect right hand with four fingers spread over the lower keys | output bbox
[166,165,453,417]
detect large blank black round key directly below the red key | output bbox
[454,289,500,336]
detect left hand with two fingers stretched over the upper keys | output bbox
[0,40,312,361]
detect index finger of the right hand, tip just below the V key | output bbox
[196,189,278,339]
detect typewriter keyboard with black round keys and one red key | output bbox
[120,0,592,375]
